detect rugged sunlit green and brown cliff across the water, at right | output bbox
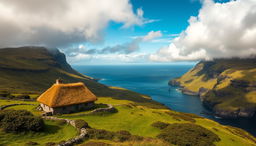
[169,58,256,118]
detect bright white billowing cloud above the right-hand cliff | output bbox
[150,0,256,62]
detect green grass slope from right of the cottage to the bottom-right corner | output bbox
[61,98,255,146]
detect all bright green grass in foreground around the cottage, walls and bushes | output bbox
[0,97,255,146]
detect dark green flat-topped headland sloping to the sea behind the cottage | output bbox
[0,47,107,93]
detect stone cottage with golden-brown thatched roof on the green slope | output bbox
[37,80,97,114]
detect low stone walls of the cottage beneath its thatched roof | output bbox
[40,102,94,114]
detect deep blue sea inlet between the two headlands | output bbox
[73,65,256,135]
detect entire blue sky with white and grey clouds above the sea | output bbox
[0,0,256,65]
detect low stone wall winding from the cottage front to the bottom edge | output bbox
[43,116,87,146]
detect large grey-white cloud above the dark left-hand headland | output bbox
[0,0,145,47]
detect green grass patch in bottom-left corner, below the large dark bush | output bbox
[0,120,77,146]
